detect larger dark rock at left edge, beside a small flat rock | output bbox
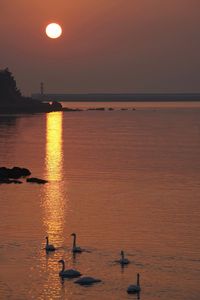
[0,167,31,179]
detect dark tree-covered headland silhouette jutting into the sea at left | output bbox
[0,68,62,114]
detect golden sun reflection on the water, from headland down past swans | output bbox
[38,112,71,300]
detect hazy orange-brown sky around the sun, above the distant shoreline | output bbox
[0,0,200,95]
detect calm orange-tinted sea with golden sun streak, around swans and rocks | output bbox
[0,103,200,300]
